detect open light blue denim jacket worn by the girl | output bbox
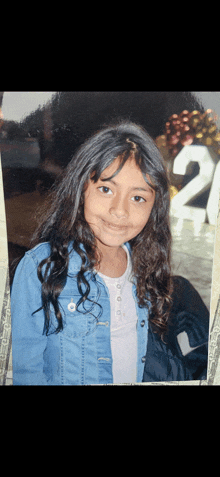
[11,243,149,385]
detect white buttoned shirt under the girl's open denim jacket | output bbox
[96,245,137,384]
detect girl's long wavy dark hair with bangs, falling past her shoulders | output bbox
[32,121,172,339]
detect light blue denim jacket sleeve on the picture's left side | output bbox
[11,252,47,385]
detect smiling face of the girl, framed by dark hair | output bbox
[84,158,155,250]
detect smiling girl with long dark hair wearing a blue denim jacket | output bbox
[11,122,210,385]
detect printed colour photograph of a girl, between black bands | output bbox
[0,91,220,386]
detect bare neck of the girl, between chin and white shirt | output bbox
[96,247,127,278]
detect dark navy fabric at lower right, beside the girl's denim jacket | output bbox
[143,276,209,382]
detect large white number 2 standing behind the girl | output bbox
[170,146,220,225]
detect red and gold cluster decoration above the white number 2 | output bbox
[156,109,220,158]
